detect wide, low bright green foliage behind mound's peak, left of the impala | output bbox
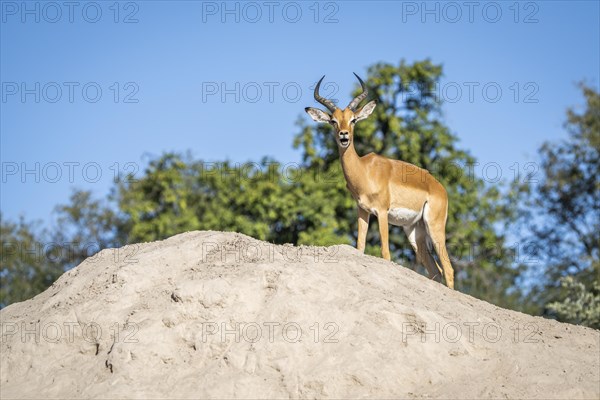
[118,154,350,244]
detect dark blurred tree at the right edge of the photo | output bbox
[519,84,600,328]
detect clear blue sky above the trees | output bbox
[0,1,600,225]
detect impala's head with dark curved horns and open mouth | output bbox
[305,74,376,149]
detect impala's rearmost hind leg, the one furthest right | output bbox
[423,203,454,289]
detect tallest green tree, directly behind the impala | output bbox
[294,60,519,308]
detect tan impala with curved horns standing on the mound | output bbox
[305,74,454,289]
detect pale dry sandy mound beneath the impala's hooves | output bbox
[0,232,600,399]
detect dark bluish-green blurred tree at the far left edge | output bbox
[0,190,120,308]
